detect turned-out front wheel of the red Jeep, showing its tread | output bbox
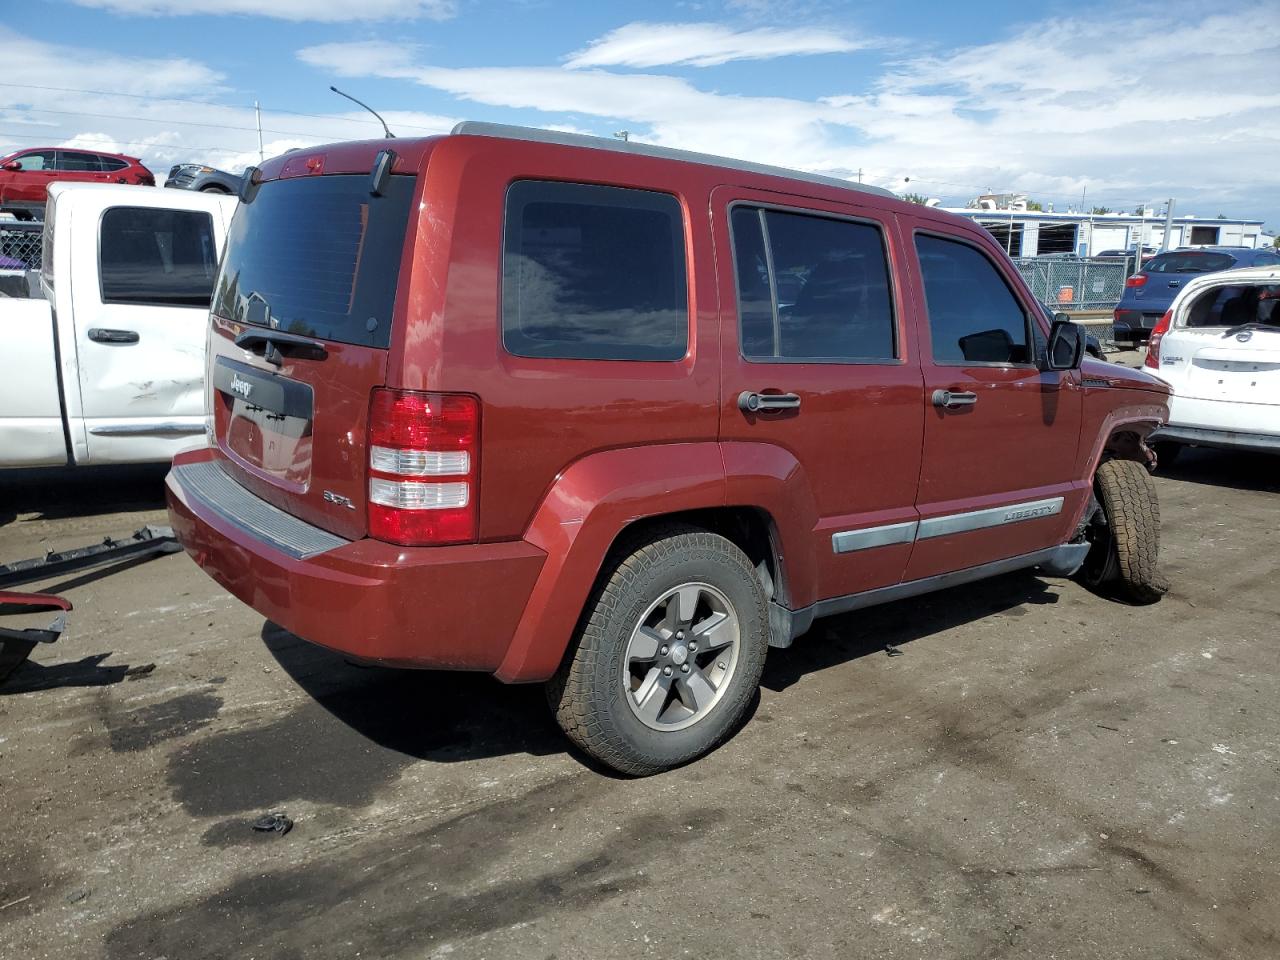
[1080,460,1169,604]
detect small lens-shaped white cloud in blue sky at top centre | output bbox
[566,23,868,67]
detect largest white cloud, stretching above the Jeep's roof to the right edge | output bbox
[293,0,1280,221]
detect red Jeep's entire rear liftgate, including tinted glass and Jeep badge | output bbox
[209,174,416,539]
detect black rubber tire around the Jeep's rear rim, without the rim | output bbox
[547,526,769,776]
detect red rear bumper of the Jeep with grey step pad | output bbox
[165,451,545,680]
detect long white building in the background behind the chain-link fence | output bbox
[946,207,1271,257]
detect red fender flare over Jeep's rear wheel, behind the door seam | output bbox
[497,440,724,684]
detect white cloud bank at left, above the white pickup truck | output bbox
[0,28,457,179]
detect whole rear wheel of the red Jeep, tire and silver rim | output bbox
[547,526,769,776]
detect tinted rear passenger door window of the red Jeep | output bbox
[731,207,893,360]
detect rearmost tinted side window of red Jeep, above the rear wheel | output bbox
[502,180,689,360]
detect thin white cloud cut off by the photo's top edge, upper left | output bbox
[72,0,458,23]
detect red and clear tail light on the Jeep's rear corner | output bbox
[369,388,480,547]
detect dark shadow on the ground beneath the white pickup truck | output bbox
[0,463,169,526]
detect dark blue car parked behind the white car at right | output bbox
[1115,247,1280,343]
